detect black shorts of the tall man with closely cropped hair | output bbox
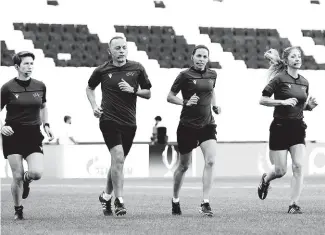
[99,120,137,156]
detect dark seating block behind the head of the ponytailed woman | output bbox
[200,27,324,70]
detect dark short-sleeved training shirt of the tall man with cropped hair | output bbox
[88,60,151,126]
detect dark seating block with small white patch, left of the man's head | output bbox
[14,23,108,67]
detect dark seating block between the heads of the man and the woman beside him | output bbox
[115,25,221,68]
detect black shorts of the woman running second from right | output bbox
[177,124,217,154]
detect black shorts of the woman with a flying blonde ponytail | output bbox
[269,118,307,150]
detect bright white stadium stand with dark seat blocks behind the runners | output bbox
[0,0,325,142]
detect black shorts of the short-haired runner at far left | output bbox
[2,125,44,159]
